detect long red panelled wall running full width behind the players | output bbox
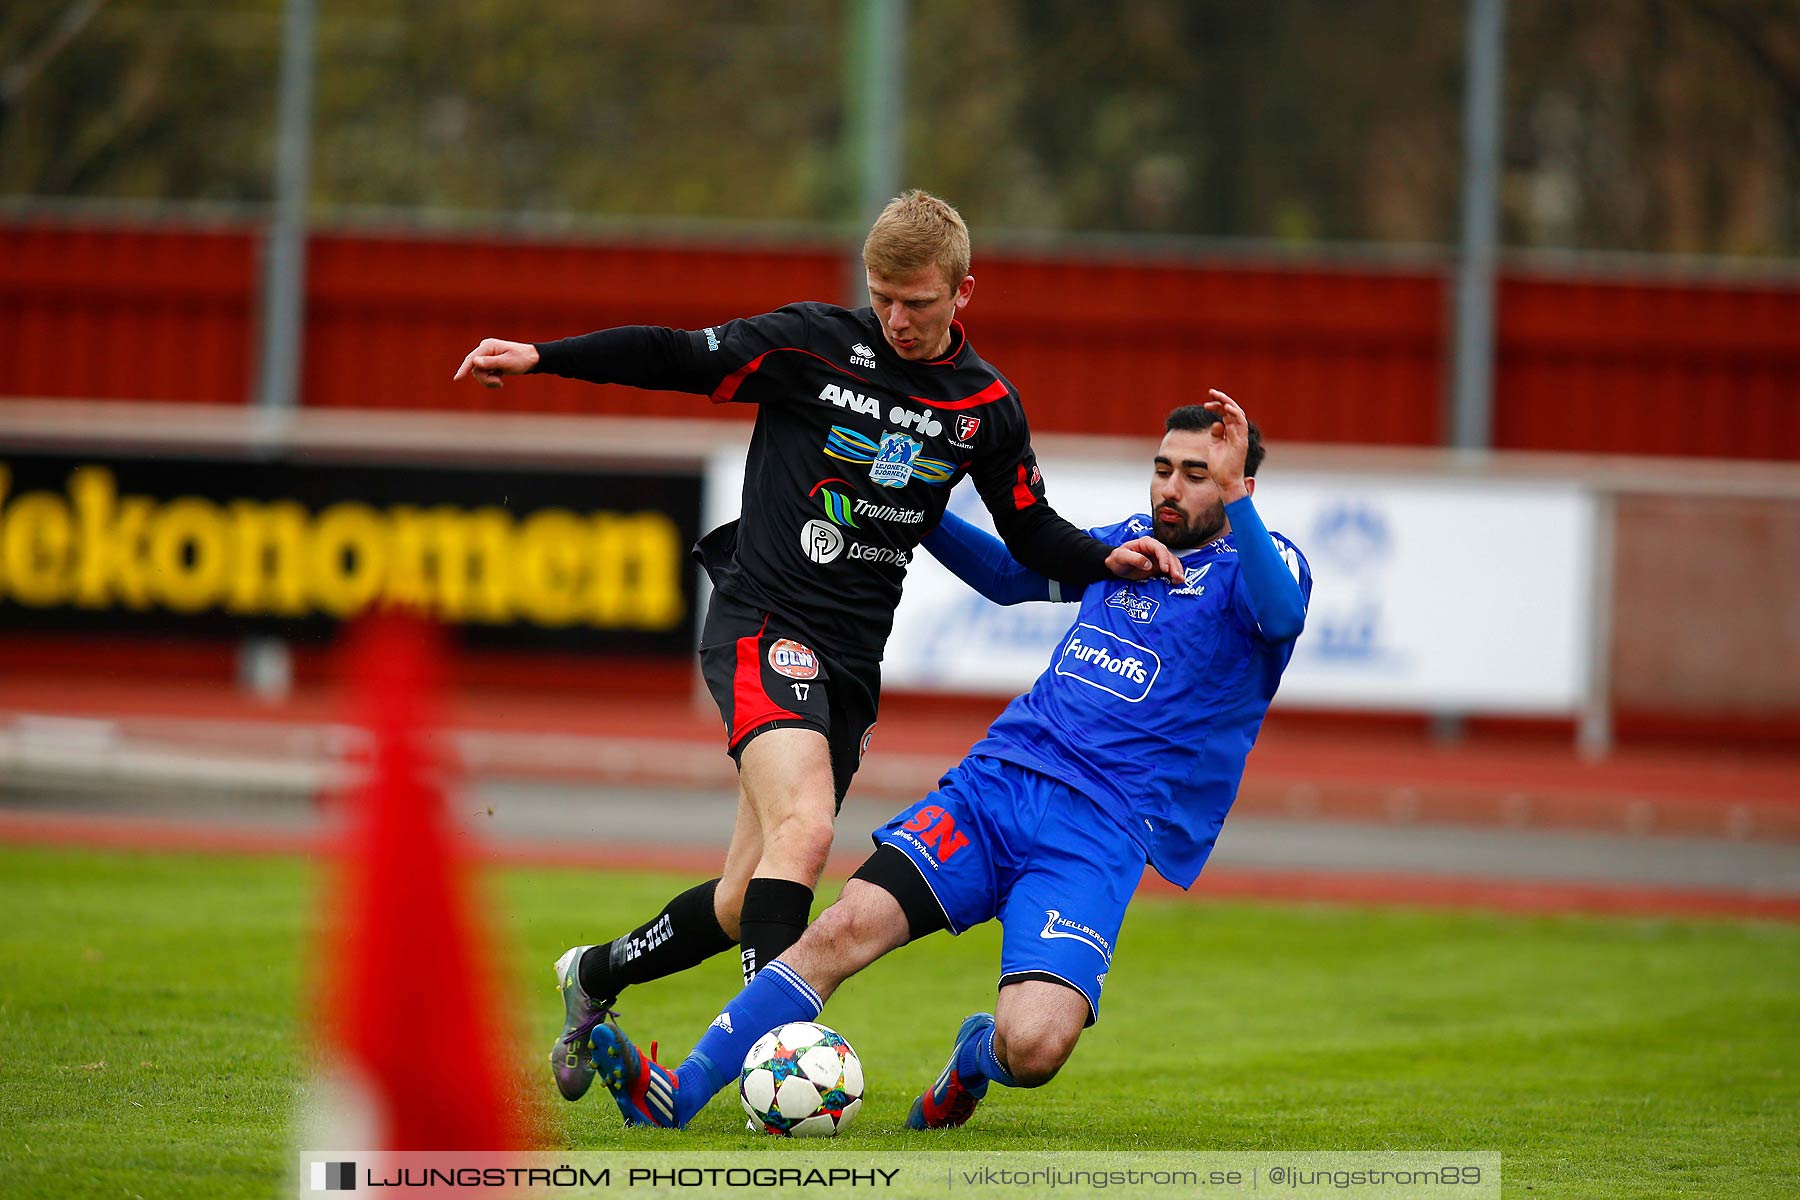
[0,219,1800,461]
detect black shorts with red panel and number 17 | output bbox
[700,590,882,808]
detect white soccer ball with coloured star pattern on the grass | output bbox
[738,1020,862,1137]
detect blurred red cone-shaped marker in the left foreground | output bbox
[324,613,524,1151]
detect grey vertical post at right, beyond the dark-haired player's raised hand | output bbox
[1449,0,1507,450]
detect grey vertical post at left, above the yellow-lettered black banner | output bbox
[238,0,317,700]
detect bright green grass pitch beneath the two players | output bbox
[0,849,1800,1198]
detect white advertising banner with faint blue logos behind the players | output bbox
[707,453,1595,714]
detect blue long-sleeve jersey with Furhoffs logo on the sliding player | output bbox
[923,498,1312,887]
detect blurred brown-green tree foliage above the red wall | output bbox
[0,0,1800,255]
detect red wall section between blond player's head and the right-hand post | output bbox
[965,257,1442,444]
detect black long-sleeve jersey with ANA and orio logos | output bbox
[536,302,1111,660]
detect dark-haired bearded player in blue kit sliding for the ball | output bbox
[592,390,1312,1130]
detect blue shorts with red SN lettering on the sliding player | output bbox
[871,757,1145,1025]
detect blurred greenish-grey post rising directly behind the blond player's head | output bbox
[844,0,905,308]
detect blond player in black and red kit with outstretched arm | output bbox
[455,191,1181,1101]
